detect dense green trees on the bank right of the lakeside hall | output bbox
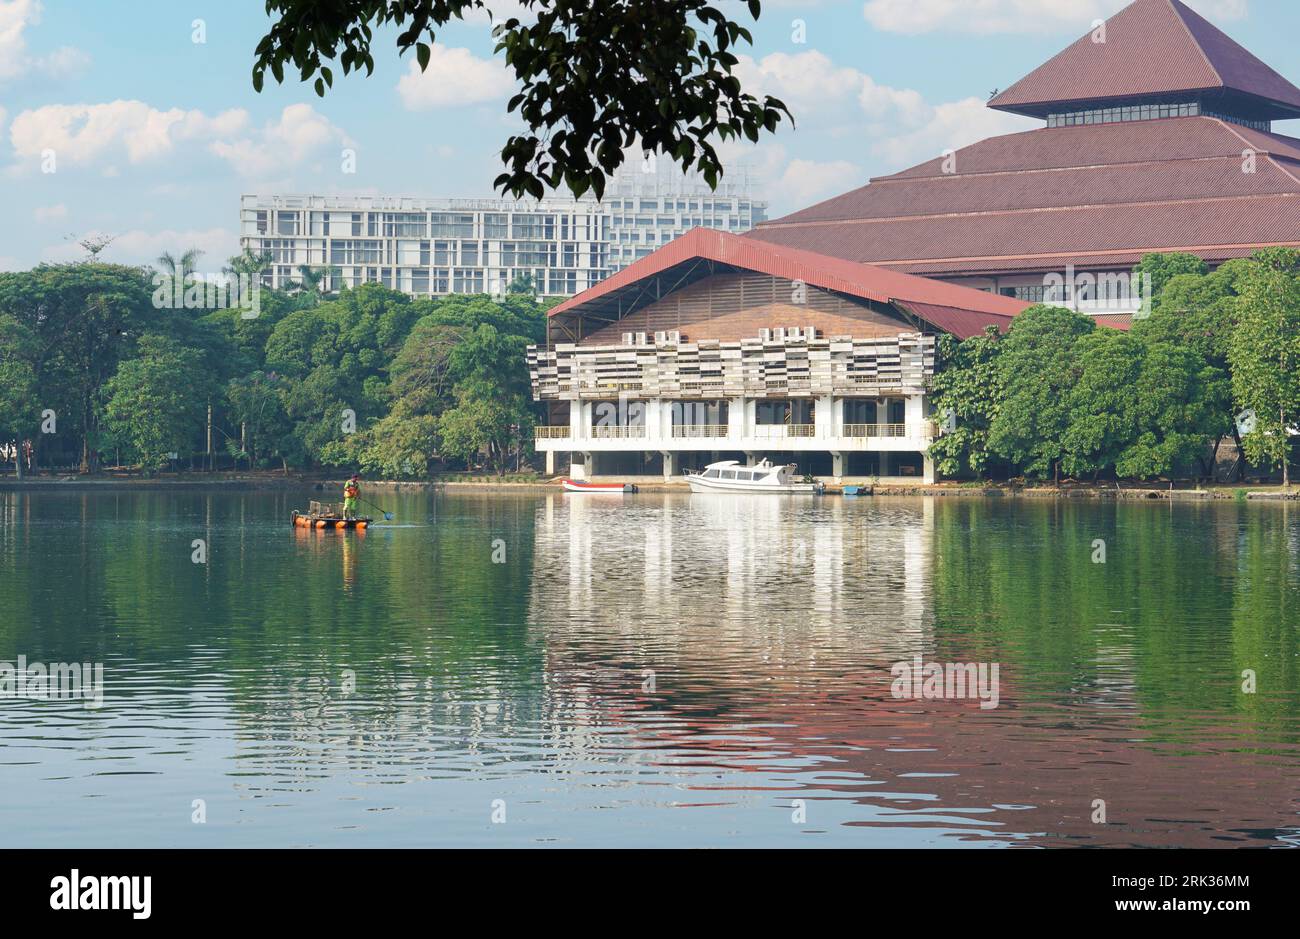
[931,248,1300,483]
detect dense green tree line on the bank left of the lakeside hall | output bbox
[0,252,547,477]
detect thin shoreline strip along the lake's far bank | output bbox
[0,476,1300,502]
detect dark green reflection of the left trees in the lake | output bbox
[0,492,542,773]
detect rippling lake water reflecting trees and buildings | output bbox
[0,492,1300,847]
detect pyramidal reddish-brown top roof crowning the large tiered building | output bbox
[989,0,1300,120]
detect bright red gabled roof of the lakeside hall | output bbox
[549,228,1030,338]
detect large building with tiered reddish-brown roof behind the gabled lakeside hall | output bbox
[754,0,1300,325]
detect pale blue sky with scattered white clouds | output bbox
[0,0,1300,272]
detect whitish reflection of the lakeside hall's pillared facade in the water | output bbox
[528,493,935,647]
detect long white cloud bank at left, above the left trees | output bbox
[9,100,348,177]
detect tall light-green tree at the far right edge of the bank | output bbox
[1229,248,1300,485]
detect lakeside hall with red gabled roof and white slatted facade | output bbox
[528,223,1026,481]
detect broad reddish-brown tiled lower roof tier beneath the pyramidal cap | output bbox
[746,117,1300,276]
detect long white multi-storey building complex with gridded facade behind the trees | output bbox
[239,165,767,297]
